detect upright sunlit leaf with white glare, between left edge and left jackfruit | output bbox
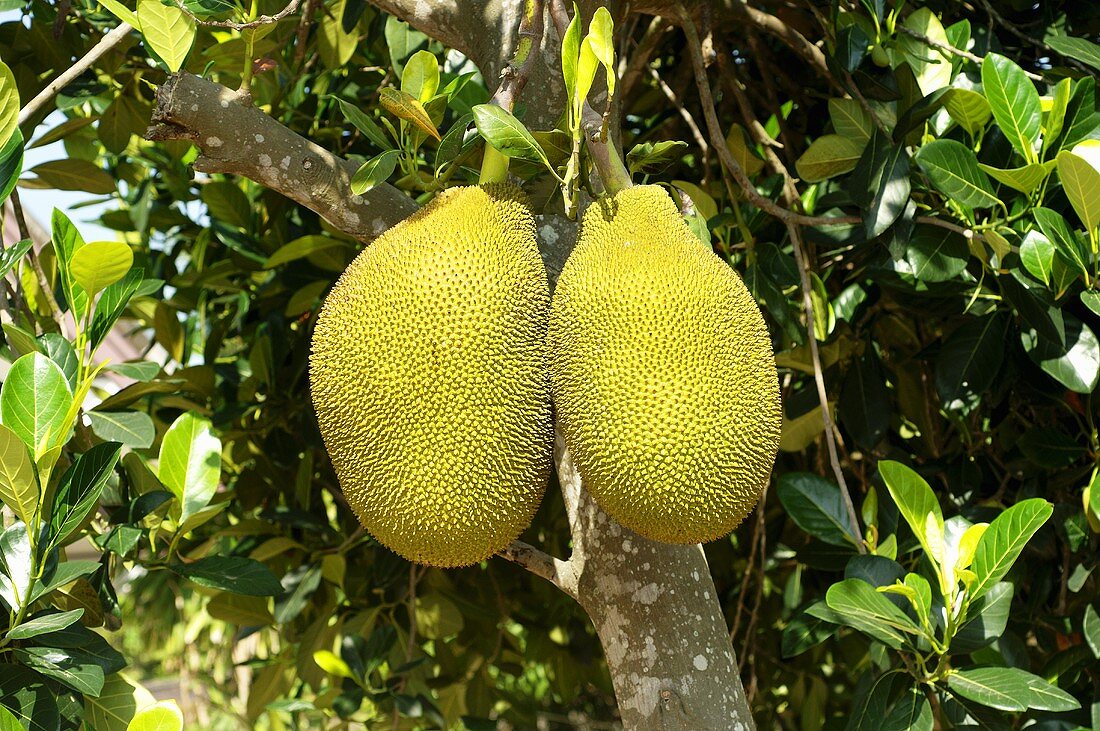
[157,412,221,523]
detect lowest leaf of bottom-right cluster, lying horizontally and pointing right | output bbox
[947,667,1080,712]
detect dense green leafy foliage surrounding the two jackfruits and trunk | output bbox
[0,0,1100,730]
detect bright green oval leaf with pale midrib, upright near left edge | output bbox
[0,353,73,459]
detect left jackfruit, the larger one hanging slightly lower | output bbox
[310,185,553,567]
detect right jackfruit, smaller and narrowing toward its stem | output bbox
[549,186,782,543]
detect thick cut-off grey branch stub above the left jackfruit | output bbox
[146,73,417,241]
